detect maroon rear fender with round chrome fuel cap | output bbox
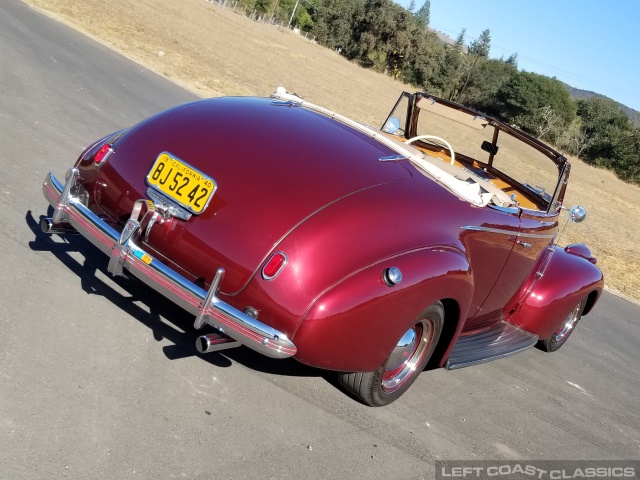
[292,248,473,372]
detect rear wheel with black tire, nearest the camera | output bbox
[338,302,444,407]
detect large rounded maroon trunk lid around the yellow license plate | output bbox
[96,97,410,294]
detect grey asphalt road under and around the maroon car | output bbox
[0,0,640,479]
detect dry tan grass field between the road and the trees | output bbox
[25,0,640,300]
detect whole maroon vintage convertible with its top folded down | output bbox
[41,88,603,406]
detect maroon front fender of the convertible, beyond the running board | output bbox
[507,245,604,338]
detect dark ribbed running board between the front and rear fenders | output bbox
[444,320,538,370]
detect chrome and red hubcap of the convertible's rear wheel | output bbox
[382,319,433,392]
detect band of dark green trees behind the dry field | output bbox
[268,0,640,184]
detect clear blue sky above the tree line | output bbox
[396,0,640,111]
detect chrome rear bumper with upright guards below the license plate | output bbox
[42,168,296,358]
